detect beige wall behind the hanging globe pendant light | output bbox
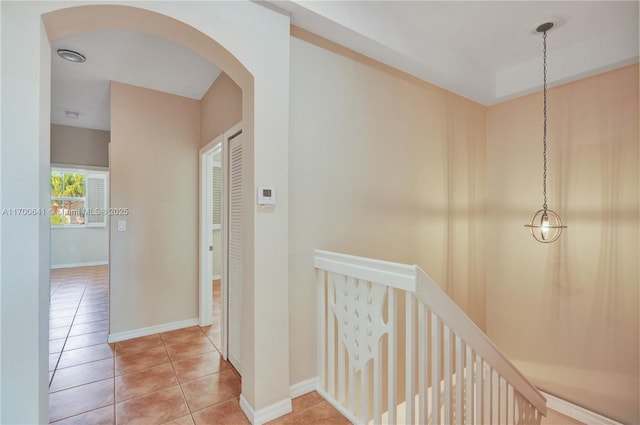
[486,65,640,424]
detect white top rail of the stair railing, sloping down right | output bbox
[314,250,547,415]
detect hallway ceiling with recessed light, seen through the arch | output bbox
[51,30,220,130]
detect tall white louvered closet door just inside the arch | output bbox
[227,130,243,373]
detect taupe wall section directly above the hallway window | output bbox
[51,124,110,167]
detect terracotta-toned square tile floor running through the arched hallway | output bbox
[49,266,349,425]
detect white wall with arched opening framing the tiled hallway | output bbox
[0,2,290,422]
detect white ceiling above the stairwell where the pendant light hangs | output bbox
[269,0,639,105]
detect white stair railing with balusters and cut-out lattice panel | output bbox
[314,250,546,425]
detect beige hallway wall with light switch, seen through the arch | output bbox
[109,83,200,335]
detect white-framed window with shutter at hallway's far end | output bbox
[51,168,107,228]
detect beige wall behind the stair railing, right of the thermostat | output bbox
[289,28,485,383]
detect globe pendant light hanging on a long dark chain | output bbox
[524,22,567,243]
